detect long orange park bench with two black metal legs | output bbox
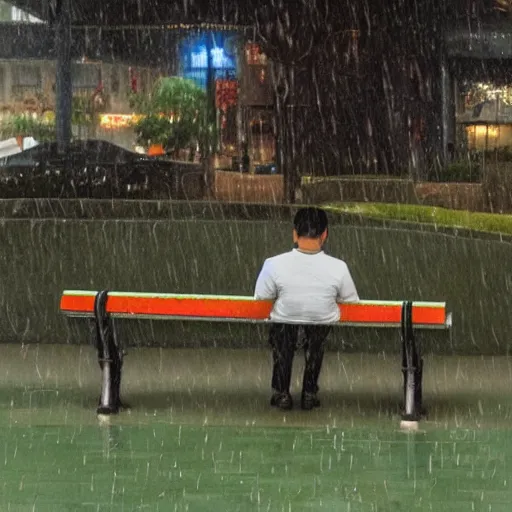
[60,290,451,423]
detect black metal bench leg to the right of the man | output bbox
[401,302,423,422]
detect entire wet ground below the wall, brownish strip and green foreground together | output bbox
[0,345,512,512]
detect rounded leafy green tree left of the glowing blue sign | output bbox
[132,77,215,160]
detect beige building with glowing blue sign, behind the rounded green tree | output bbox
[0,2,275,169]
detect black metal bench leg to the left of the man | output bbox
[94,290,123,414]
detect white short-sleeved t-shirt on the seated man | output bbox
[254,249,359,324]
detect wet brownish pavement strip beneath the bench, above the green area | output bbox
[0,345,512,428]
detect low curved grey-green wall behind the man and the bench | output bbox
[0,201,512,354]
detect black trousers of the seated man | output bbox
[269,324,331,393]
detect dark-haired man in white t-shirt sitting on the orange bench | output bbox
[254,208,359,410]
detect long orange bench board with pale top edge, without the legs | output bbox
[60,290,451,329]
